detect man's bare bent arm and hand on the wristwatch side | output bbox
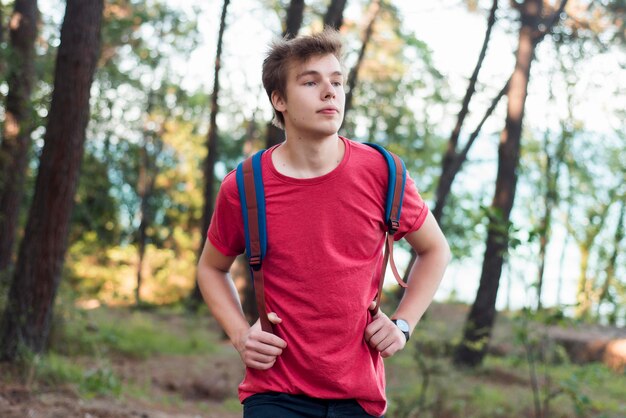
[365,212,450,357]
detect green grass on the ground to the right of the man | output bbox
[385,304,626,418]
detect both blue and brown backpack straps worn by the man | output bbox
[236,143,407,333]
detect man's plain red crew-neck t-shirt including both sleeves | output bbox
[208,138,428,416]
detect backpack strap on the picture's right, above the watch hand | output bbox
[365,142,407,315]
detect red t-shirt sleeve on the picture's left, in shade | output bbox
[207,171,246,257]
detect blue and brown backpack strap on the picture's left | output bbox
[236,150,273,332]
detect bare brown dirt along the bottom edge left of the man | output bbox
[0,350,243,418]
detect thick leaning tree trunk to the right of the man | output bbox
[454,0,543,366]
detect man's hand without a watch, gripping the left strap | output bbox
[235,312,287,370]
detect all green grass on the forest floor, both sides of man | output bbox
[3,302,626,418]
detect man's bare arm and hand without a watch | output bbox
[198,239,287,370]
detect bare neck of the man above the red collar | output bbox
[272,134,345,178]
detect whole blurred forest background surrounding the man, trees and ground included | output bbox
[0,0,626,418]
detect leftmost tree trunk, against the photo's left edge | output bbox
[0,0,39,277]
